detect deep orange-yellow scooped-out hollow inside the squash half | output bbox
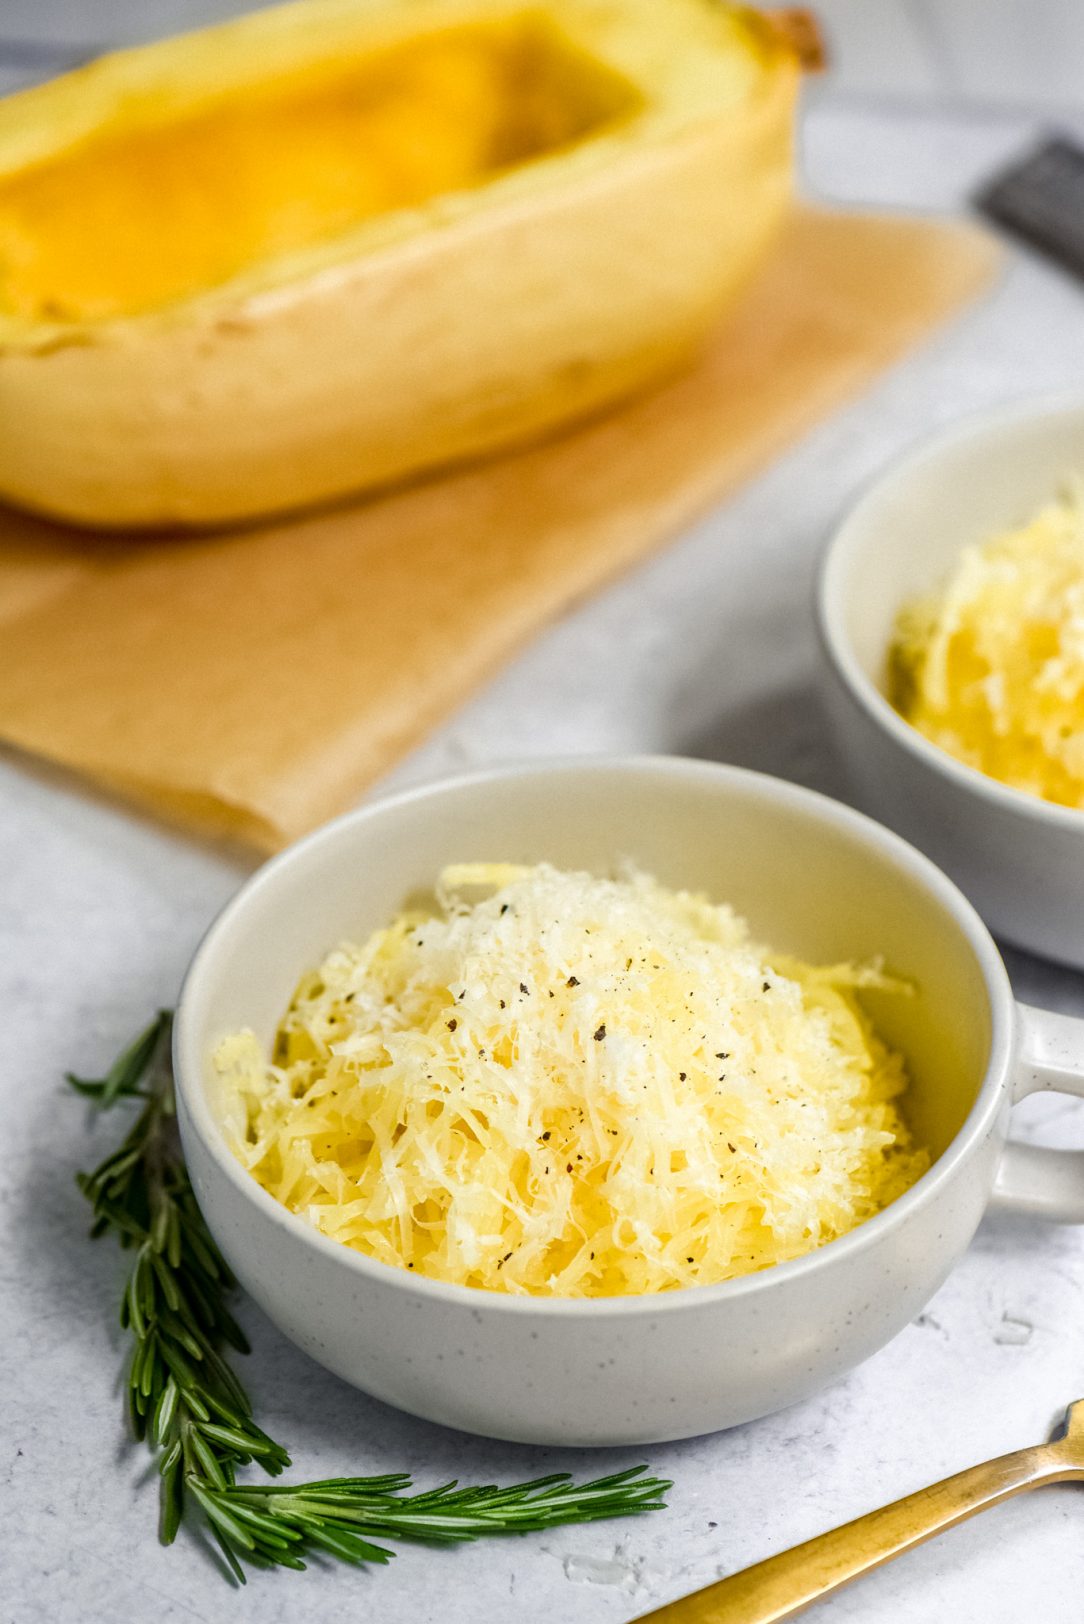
[0,16,640,322]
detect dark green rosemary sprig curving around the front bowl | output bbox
[68,1010,670,1583]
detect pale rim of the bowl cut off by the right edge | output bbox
[814,390,1084,836]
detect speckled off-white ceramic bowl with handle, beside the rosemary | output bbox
[174,758,1084,1444]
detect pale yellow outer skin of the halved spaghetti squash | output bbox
[0,0,798,529]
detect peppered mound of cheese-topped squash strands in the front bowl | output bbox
[216,864,928,1296]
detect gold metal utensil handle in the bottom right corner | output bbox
[634,1398,1084,1624]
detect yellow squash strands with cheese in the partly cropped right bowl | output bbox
[889,483,1084,809]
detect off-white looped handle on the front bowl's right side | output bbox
[990,1004,1084,1223]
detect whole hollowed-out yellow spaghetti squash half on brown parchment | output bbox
[0,0,798,528]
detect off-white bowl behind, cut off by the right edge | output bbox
[817,395,1084,968]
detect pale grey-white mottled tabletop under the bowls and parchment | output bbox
[0,9,1084,1624]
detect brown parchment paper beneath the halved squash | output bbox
[0,209,996,849]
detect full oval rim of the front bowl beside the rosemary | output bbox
[172,754,1017,1319]
